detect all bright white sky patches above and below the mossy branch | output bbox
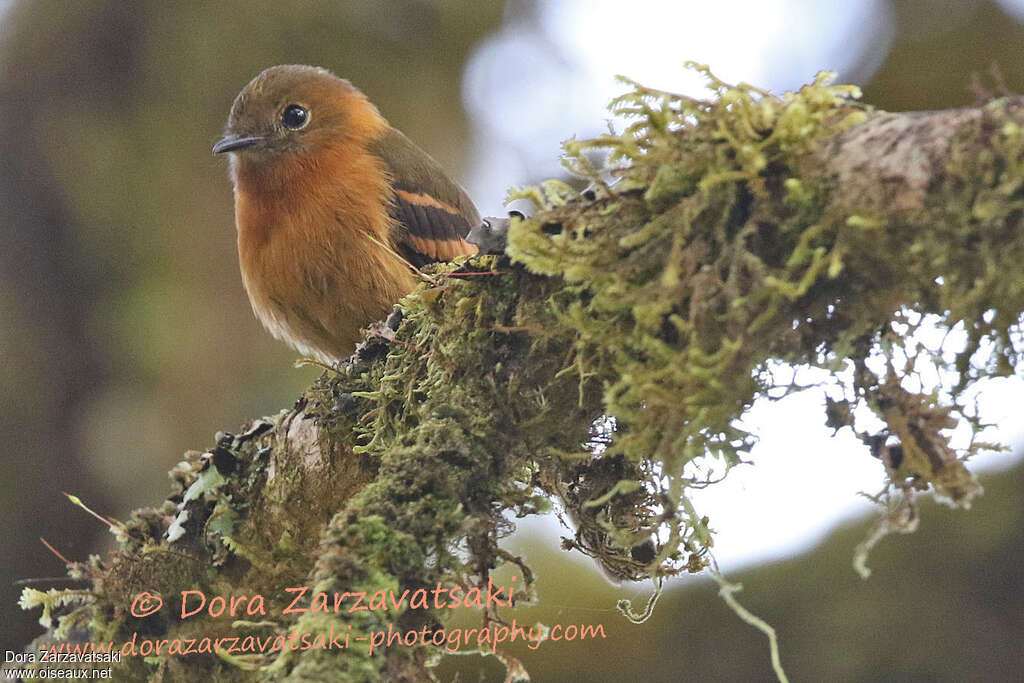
[464,0,1024,570]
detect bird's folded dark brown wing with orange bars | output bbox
[370,128,480,266]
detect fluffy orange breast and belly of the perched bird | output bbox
[234,140,416,361]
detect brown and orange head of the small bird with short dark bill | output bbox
[213,65,386,171]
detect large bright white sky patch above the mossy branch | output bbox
[463,0,892,215]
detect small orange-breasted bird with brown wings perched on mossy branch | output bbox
[213,65,480,364]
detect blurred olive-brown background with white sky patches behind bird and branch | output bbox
[0,0,1024,681]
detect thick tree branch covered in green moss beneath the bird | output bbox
[18,68,1024,681]
